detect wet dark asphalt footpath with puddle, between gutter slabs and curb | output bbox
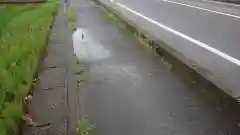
[72,0,240,135]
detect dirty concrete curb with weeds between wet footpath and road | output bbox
[94,0,239,101]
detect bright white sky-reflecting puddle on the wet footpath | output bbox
[72,29,110,61]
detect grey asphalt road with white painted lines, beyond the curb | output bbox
[100,0,240,98]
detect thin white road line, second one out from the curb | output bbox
[159,0,240,19]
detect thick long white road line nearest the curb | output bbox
[116,2,240,66]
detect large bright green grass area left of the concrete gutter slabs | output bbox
[0,0,58,135]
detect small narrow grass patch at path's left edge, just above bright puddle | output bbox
[67,7,76,32]
